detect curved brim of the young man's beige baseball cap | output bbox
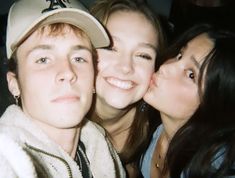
[11,8,110,50]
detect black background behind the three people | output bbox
[0,0,235,116]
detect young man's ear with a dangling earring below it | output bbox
[7,72,20,96]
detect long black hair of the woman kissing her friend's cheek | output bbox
[166,25,235,178]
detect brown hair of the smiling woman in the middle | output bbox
[91,0,165,169]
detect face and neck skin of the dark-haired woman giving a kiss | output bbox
[144,34,213,177]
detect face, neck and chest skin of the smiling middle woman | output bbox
[92,10,159,178]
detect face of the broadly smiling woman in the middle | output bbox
[96,11,157,119]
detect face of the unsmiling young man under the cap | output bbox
[8,26,94,129]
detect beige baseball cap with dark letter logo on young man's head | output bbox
[6,0,110,59]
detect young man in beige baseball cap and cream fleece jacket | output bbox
[0,0,125,178]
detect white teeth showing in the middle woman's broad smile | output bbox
[105,77,136,90]
